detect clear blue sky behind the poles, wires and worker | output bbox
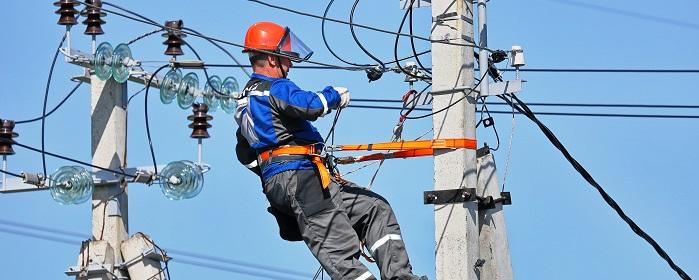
[0,0,699,279]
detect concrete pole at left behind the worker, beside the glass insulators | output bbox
[85,74,128,279]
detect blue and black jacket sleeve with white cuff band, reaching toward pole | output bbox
[270,79,340,121]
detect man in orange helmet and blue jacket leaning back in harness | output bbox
[236,22,427,280]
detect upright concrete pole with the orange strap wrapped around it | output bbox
[431,0,479,280]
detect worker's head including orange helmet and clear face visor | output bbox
[243,22,313,78]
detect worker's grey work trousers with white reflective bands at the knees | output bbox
[264,170,417,280]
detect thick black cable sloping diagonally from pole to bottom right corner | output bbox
[500,94,691,280]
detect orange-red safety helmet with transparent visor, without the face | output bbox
[243,21,313,62]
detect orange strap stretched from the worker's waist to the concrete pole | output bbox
[334,139,477,164]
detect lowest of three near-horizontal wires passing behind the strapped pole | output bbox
[347,104,699,119]
